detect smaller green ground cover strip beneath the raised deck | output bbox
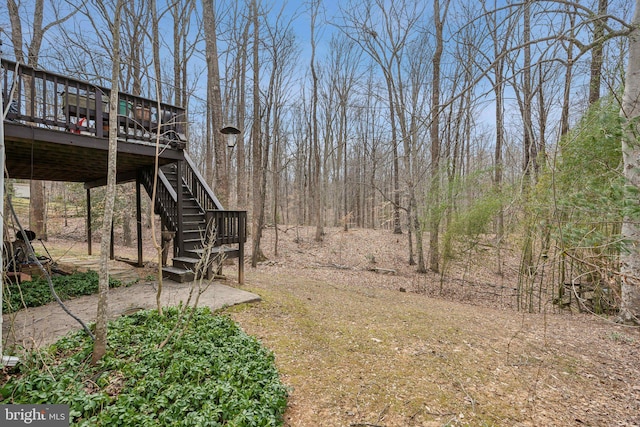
[2,271,123,313]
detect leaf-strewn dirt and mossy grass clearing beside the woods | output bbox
[5,222,640,427]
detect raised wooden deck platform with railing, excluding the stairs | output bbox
[0,60,186,188]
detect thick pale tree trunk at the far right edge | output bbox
[618,0,640,325]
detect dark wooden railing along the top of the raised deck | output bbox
[0,59,186,149]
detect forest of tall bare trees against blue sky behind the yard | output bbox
[0,0,640,322]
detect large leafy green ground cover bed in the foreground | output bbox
[0,308,287,426]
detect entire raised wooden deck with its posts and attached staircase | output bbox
[0,59,247,283]
